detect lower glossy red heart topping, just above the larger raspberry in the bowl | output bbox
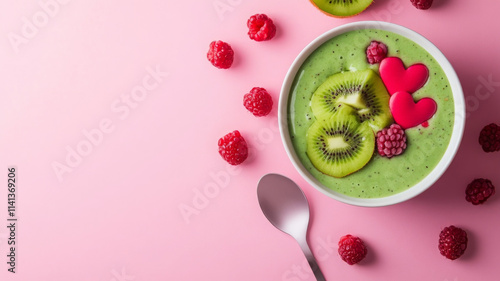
[389,92,437,129]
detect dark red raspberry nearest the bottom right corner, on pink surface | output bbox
[438,225,467,260]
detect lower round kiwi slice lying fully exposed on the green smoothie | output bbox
[307,104,375,178]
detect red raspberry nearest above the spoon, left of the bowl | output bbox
[219,130,248,165]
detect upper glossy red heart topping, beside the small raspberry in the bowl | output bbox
[379,57,429,96]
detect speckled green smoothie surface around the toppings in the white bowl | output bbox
[288,29,455,198]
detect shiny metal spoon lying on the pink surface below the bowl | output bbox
[257,174,326,281]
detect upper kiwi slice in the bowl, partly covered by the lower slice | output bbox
[311,69,393,132]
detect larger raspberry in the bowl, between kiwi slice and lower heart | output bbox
[377,124,406,158]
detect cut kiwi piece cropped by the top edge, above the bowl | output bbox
[311,0,373,18]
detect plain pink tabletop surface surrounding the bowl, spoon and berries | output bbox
[0,0,500,281]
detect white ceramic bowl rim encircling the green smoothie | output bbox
[278,21,465,207]
